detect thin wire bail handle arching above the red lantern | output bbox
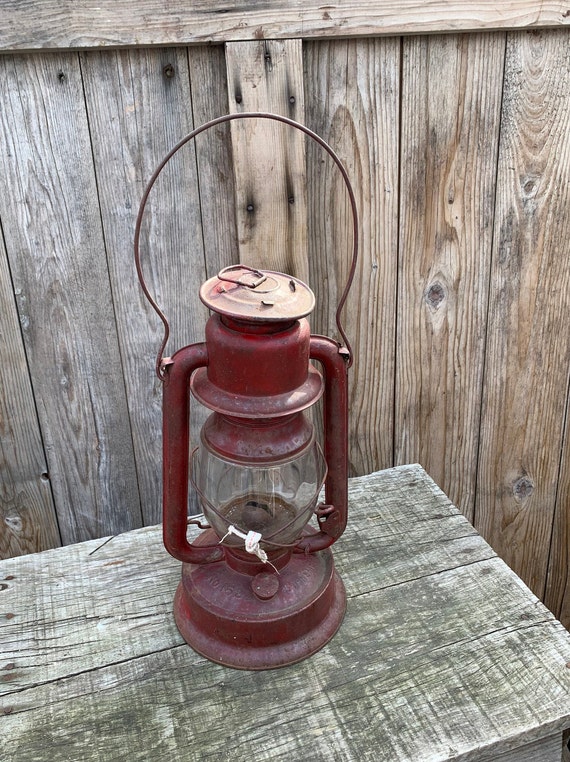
[134,111,358,381]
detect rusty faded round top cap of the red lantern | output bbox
[200,265,315,323]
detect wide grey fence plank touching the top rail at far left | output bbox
[0,54,140,543]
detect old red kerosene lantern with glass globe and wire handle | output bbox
[135,113,358,669]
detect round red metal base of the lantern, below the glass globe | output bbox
[174,530,346,670]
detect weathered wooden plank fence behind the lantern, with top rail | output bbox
[0,0,570,624]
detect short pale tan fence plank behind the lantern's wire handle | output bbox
[226,40,308,281]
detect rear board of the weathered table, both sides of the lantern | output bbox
[0,460,495,695]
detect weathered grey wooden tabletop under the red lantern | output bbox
[0,466,570,762]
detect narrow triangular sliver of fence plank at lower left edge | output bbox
[0,229,60,558]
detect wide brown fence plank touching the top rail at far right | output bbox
[475,31,570,596]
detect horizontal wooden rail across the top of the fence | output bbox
[0,0,570,50]
